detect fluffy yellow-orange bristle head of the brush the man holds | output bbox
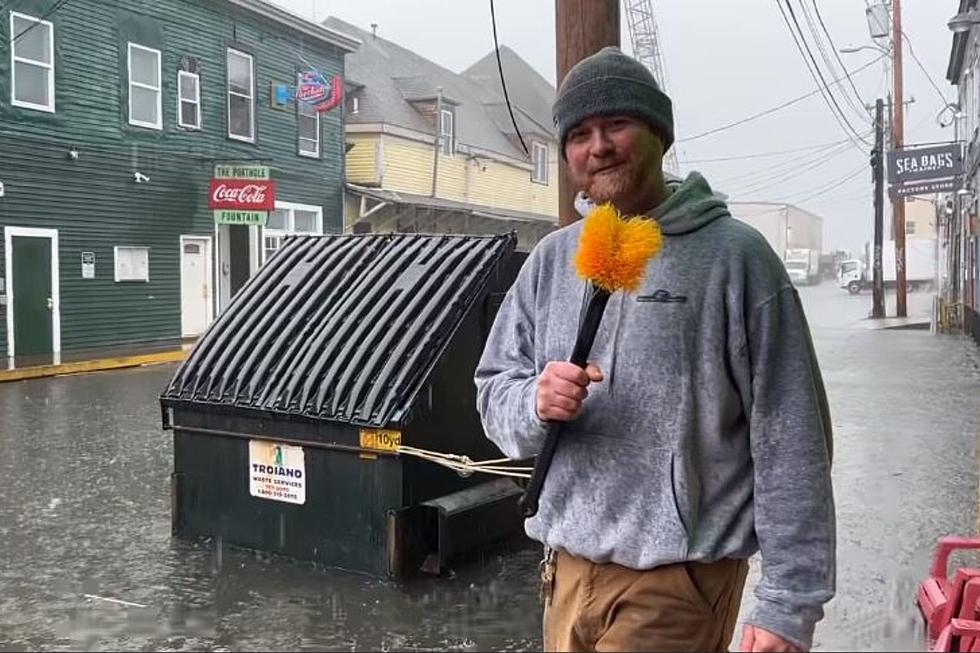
[575,204,663,292]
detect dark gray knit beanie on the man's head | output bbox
[552,46,674,157]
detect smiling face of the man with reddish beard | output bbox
[565,116,663,209]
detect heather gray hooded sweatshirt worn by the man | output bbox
[476,173,835,648]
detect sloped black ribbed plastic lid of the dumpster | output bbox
[161,234,516,427]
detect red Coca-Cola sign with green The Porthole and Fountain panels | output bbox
[208,165,276,227]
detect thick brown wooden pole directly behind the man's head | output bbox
[555,0,620,227]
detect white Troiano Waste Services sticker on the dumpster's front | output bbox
[248,440,306,504]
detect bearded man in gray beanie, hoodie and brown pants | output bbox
[476,48,835,651]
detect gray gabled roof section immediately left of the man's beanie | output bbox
[462,45,557,138]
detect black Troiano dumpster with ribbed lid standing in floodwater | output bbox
[160,234,520,576]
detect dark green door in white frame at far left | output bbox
[10,236,55,357]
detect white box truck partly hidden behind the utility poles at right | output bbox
[837,239,936,295]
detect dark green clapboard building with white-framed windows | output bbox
[0,0,358,361]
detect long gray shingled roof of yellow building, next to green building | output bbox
[323,17,550,161]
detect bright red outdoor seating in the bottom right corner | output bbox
[916,537,980,651]
